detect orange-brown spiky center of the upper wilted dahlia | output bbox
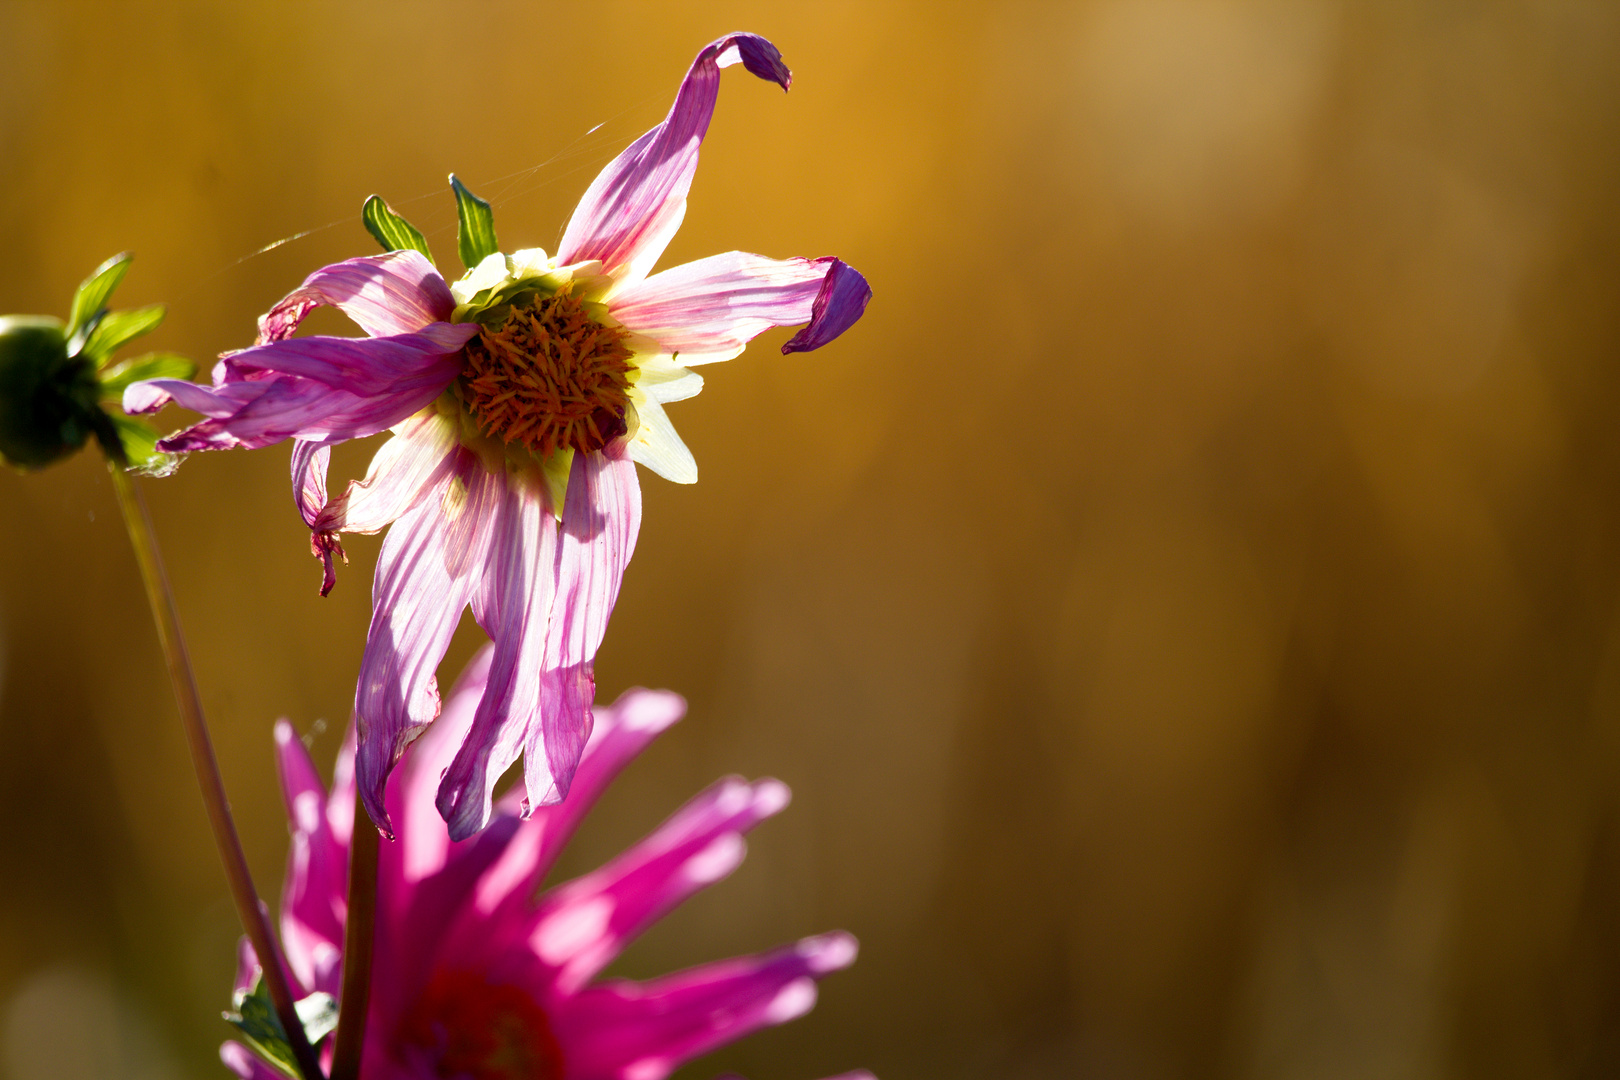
[462,288,630,458]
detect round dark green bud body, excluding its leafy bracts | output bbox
[0,316,110,468]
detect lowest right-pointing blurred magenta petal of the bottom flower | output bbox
[554,933,859,1080]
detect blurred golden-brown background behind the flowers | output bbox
[0,0,1620,1080]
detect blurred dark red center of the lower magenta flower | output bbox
[397,972,562,1080]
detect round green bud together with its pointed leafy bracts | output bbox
[0,253,196,473]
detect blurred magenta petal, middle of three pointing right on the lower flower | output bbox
[528,777,789,993]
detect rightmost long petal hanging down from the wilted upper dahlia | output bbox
[523,445,642,805]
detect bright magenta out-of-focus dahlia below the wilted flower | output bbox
[230,648,855,1080]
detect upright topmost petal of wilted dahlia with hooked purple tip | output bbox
[557,34,792,283]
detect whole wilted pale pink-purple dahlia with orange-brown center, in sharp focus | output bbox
[125,34,872,839]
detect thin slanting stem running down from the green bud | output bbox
[107,461,322,1080]
